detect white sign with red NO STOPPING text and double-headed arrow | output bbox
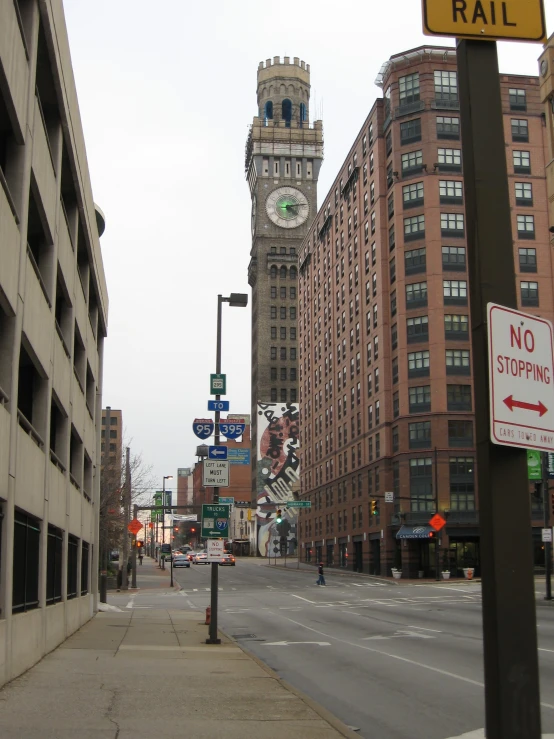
[487,303,554,451]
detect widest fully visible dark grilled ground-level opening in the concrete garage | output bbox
[12,510,40,613]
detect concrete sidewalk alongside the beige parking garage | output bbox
[0,557,357,739]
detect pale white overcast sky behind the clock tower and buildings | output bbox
[64,0,554,498]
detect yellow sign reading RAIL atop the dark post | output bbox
[422,0,546,42]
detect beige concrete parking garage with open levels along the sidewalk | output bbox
[0,0,108,684]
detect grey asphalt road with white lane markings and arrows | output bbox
[110,559,554,739]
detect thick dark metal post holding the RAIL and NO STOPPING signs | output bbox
[457,40,541,739]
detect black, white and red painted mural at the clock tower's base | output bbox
[256,403,300,557]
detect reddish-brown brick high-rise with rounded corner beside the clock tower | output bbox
[299,47,554,577]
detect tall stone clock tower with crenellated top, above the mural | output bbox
[245,56,323,500]
